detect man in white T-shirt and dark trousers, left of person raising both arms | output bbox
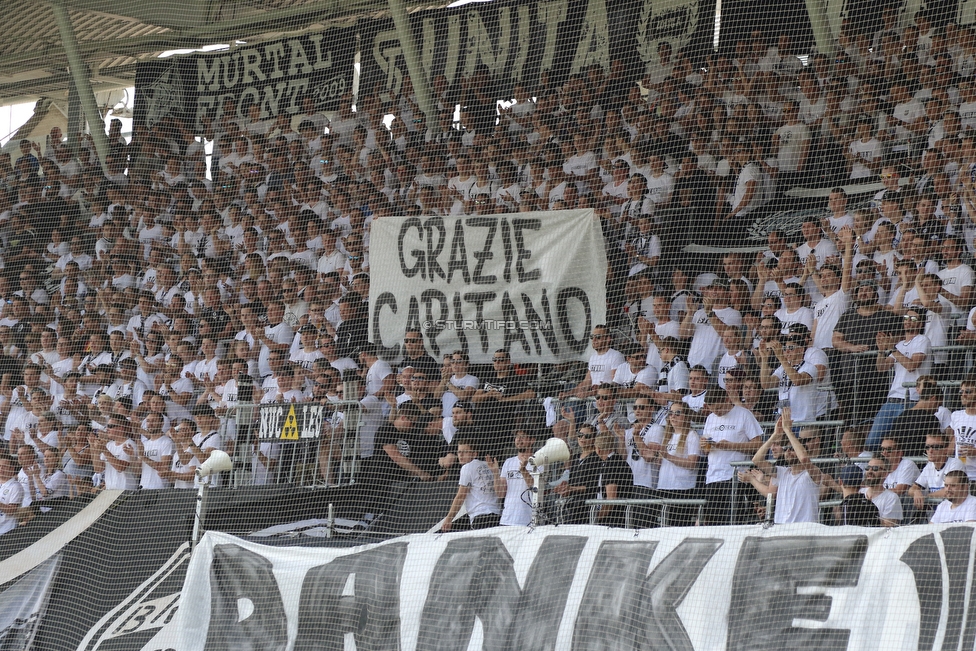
[702,385,762,524]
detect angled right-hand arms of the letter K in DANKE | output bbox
[635,538,725,651]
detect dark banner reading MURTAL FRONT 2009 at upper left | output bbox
[134,28,356,128]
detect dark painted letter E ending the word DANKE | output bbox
[726,536,868,651]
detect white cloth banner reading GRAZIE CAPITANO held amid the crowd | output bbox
[369,210,607,363]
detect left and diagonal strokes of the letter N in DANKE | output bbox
[417,537,521,651]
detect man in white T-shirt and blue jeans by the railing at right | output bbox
[867,307,932,450]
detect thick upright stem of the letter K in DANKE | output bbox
[572,540,657,651]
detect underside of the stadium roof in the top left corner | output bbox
[0,0,443,105]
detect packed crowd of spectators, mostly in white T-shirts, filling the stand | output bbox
[7,12,976,532]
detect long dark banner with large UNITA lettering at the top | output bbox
[360,0,714,98]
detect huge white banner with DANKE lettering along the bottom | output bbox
[143,524,976,651]
